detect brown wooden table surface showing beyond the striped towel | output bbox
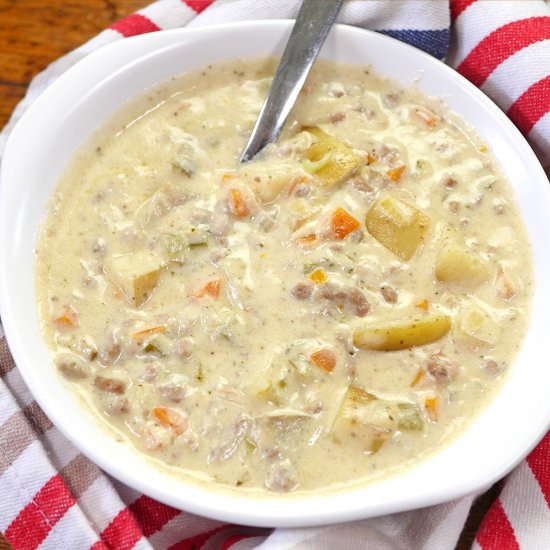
[0,0,497,550]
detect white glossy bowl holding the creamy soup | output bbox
[0,21,550,527]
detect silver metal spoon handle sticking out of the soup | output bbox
[240,0,344,162]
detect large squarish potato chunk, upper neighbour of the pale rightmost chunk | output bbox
[365,194,430,261]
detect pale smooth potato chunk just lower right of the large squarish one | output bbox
[435,240,489,287]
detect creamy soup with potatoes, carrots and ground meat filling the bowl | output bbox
[37,60,532,493]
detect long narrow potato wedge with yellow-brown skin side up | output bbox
[353,314,451,351]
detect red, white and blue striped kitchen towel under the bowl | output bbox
[0,0,550,550]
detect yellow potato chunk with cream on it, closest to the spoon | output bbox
[304,128,362,188]
